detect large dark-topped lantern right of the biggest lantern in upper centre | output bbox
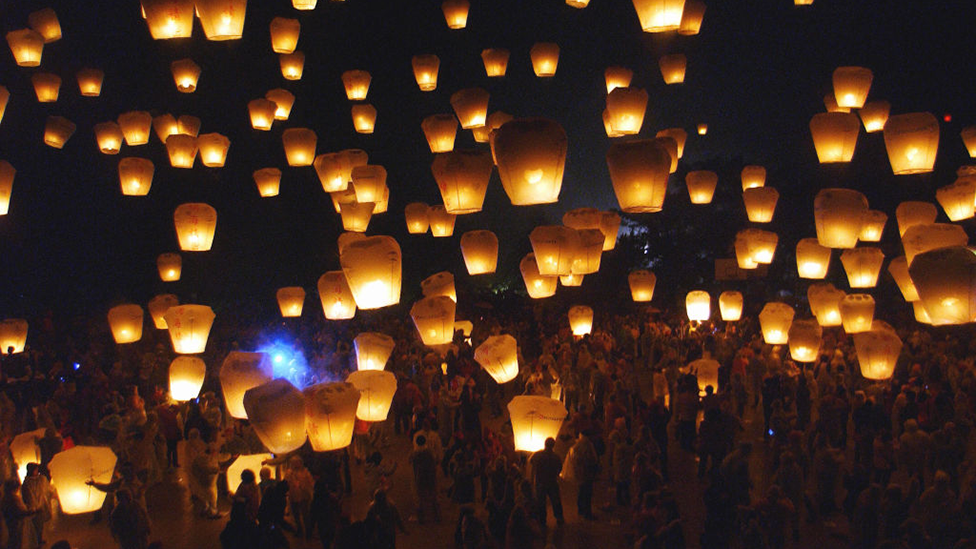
[607,139,671,213]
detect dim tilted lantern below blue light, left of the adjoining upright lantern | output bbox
[243,379,306,455]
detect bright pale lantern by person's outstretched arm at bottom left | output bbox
[48,446,116,515]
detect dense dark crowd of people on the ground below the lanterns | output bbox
[0,296,976,549]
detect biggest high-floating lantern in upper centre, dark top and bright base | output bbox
[492,118,568,206]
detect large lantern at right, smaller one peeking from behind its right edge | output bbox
[813,189,868,248]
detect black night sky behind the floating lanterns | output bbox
[0,0,976,317]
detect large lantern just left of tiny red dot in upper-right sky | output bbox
[884,112,939,175]
